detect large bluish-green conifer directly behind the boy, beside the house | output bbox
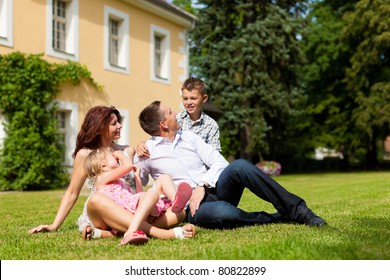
[191,0,304,162]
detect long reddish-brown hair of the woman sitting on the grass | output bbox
[72,106,121,158]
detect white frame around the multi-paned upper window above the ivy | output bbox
[46,0,79,61]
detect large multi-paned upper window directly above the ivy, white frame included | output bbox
[46,0,79,61]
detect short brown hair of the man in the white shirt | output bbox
[138,101,164,136]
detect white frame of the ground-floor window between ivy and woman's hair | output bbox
[56,101,78,168]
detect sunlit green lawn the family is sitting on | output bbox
[0,172,390,260]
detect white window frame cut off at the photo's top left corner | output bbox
[0,0,14,47]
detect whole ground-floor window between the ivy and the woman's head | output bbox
[57,101,78,168]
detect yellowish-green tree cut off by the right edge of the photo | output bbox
[341,0,390,168]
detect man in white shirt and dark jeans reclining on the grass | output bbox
[135,101,326,228]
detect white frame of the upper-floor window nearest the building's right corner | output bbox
[150,24,171,84]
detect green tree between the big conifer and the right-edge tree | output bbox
[301,0,354,165]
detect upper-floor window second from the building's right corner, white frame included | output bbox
[104,6,130,74]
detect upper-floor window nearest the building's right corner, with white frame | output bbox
[150,25,171,84]
